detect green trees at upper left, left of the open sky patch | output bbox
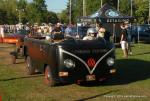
[0,0,58,24]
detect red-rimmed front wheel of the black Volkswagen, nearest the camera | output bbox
[44,65,56,87]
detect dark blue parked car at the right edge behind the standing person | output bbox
[128,25,150,43]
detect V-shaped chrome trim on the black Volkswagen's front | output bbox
[60,48,115,74]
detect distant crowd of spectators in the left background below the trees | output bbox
[0,23,64,36]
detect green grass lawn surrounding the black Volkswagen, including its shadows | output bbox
[0,44,150,101]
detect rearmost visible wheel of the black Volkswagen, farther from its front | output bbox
[26,56,35,75]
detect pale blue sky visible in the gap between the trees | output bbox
[28,0,68,13]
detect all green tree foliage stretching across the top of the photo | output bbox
[0,0,149,24]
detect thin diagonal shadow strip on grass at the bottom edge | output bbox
[75,90,119,101]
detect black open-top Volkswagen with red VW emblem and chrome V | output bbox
[24,34,116,86]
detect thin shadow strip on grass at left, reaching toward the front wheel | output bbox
[0,74,43,82]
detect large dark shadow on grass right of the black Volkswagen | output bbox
[106,59,150,85]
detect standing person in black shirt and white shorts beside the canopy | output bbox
[120,23,128,58]
